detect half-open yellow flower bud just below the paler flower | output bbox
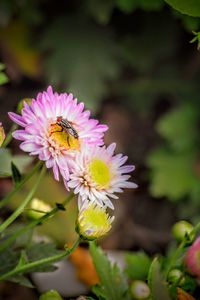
[76,202,114,241]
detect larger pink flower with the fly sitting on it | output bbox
[9,86,108,186]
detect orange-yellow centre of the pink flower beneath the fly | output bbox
[49,123,80,150]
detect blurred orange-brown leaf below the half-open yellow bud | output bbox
[70,247,99,286]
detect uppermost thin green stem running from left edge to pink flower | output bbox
[0,161,42,209]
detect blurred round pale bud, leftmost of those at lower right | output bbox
[131,280,150,300]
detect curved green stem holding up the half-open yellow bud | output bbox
[0,237,81,280]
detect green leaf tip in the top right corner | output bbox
[165,0,200,17]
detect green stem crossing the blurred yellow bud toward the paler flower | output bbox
[0,193,74,252]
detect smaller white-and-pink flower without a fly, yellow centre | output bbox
[68,143,137,209]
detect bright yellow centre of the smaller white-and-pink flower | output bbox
[89,159,110,188]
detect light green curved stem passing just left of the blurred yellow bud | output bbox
[0,165,46,233]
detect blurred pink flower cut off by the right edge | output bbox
[185,237,200,278]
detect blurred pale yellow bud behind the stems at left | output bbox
[27,198,52,219]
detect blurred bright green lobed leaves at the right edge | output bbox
[147,104,200,220]
